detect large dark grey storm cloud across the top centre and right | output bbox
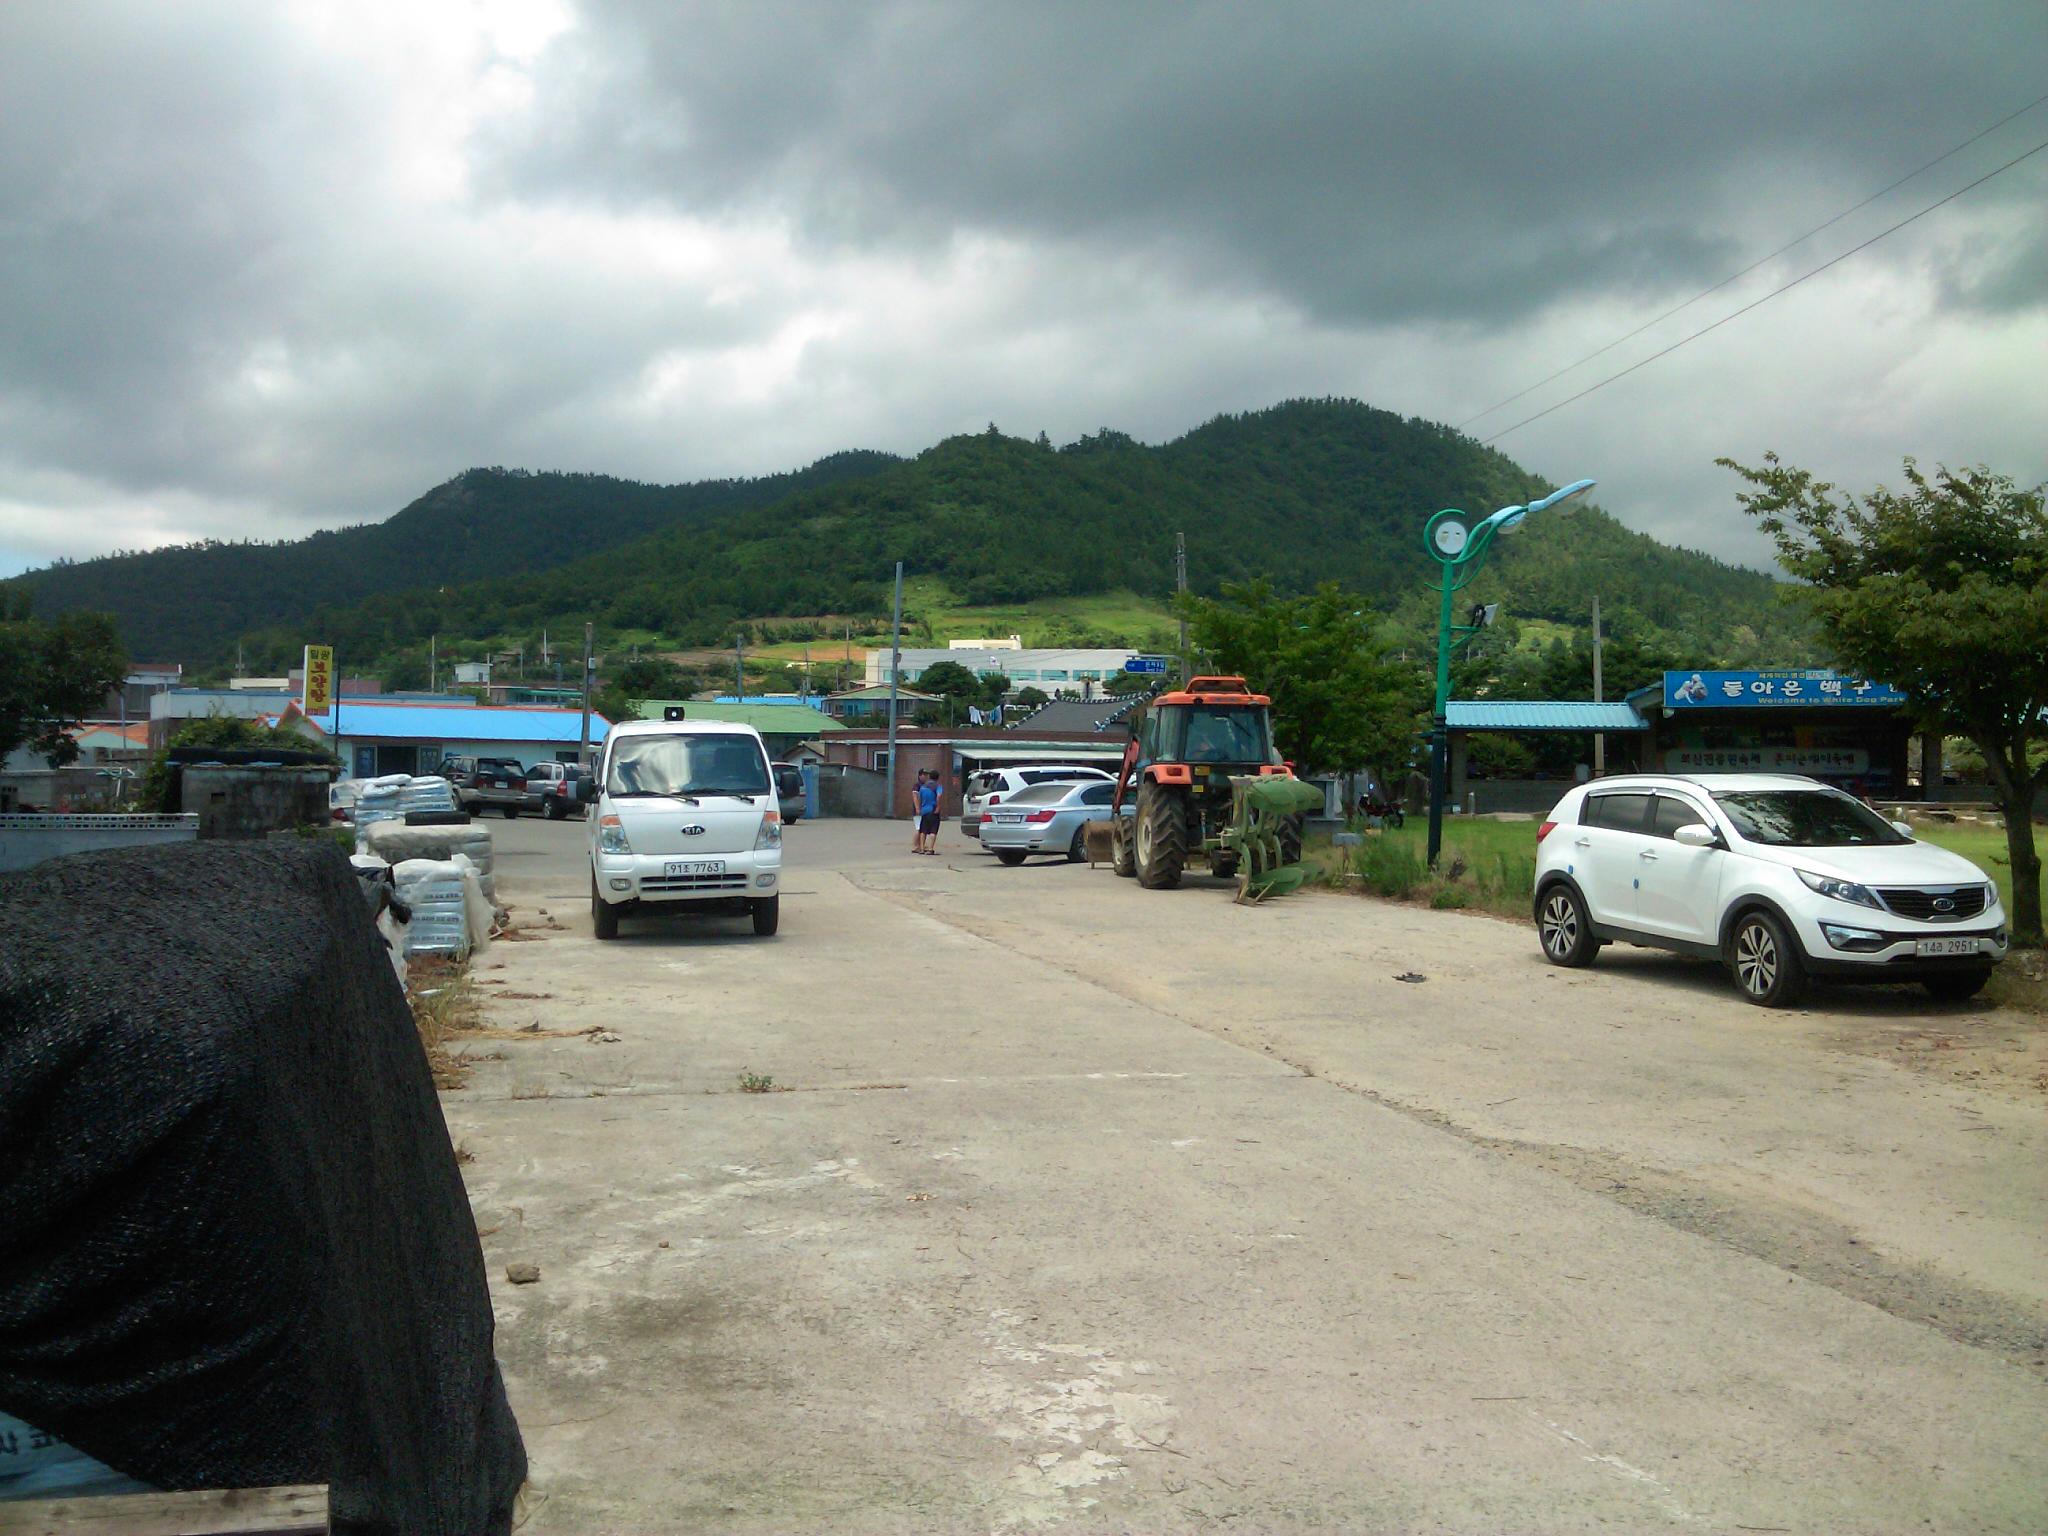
[498,0,2048,326]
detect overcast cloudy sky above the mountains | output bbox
[0,0,2048,573]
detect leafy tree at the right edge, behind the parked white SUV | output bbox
[1718,453,2048,946]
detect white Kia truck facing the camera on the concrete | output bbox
[590,711,782,938]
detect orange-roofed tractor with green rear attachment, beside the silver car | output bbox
[1110,678,1323,899]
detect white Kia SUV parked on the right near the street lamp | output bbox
[1536,774,2009,1008]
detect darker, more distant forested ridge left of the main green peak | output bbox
[14,453,897,664]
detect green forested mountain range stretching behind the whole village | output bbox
[8,399,1792,666]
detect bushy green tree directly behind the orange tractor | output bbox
[1184,582,1419,772]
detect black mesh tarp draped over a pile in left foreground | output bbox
[0,840,526,1536]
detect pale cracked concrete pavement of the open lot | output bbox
[444,821,2048,1532]
